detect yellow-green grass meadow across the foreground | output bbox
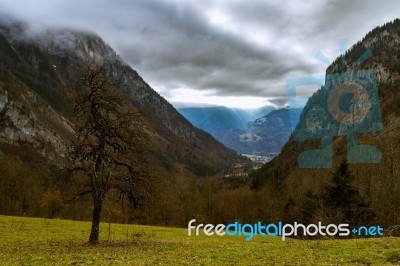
[0,216,400,265]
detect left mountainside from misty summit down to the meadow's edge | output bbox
[0,23,251,224]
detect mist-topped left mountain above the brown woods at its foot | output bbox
[0,23,247,176]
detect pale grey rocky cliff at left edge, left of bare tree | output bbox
[0,64,74,157]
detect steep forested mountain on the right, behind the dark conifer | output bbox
[251,19,400,226]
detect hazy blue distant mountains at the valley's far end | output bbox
[178,106,301,155]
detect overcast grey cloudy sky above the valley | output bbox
[0,0,400,108]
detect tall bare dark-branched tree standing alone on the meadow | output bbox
[69,65,151,244]
